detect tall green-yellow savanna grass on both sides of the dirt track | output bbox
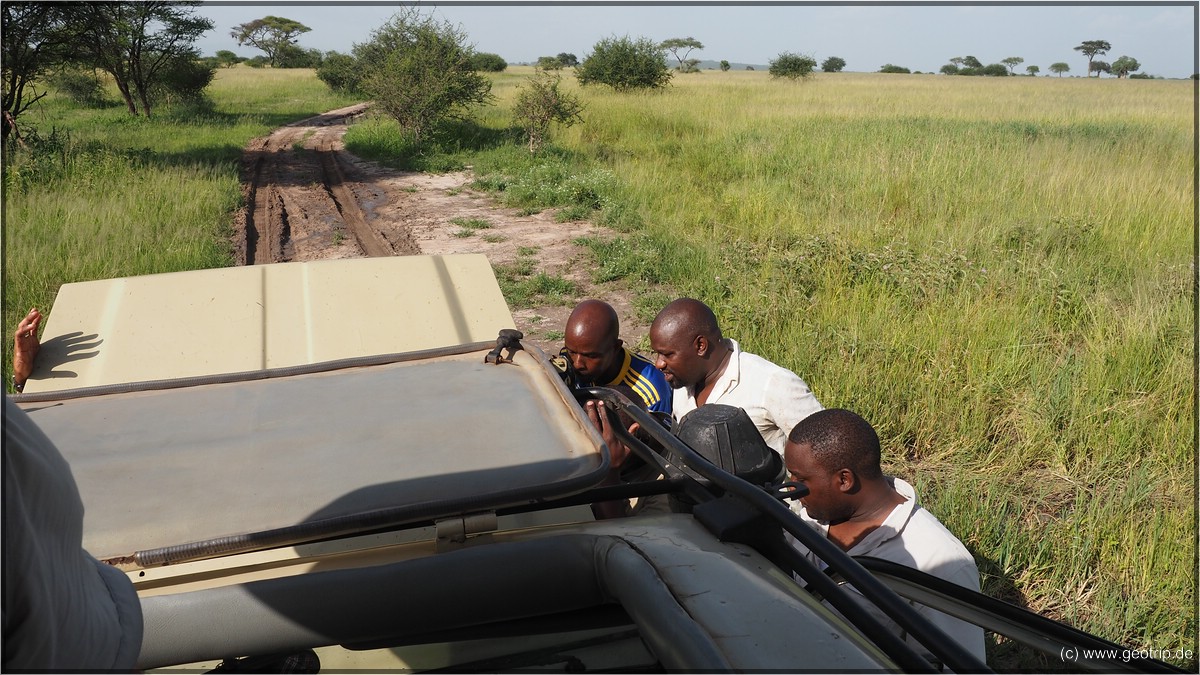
[4,67,1196,669]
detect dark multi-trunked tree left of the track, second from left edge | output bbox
[73,0,212,117]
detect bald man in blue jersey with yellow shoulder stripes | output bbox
[560,300,672,414]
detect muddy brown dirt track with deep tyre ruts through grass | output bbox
[234,103,647,352]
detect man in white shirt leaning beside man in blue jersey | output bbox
[650,298,821,455]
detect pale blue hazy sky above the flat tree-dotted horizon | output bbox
[197,2,1198,77]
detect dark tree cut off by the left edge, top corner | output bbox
[0,2,78,141]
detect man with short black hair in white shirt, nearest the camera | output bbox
[784,408,985,661]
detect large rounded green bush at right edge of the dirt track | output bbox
[354,7,492,144]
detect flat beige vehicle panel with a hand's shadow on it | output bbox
[25,255,514,393]
